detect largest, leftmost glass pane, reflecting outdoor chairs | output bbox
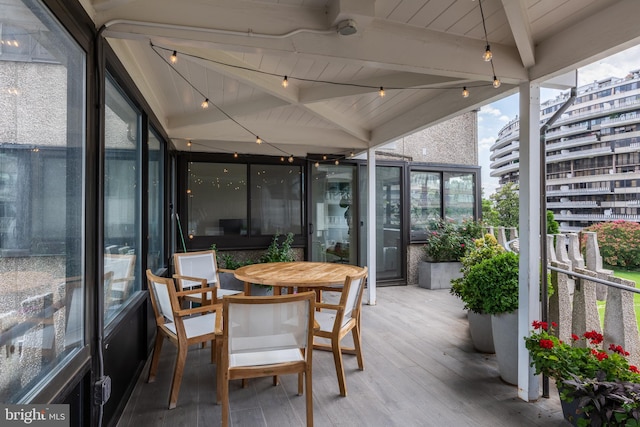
[0,0,86,403]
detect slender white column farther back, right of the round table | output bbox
[366,148,377,305]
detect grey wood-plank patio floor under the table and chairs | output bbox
[118,286,569,427]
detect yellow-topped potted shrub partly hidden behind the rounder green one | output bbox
[450,234,505,353]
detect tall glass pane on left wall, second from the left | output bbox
[103,78,141,325]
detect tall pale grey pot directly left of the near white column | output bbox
[491,310,518,385]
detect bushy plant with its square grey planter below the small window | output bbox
[418,220,482,289]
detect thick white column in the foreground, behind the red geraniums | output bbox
[518,82,543,401]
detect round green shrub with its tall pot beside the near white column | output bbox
[465,252,519,384]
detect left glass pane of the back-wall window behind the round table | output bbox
[185,162,247,236]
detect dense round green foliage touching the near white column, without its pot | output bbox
[465,252,518,314]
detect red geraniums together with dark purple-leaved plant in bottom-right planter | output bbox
[524,321,640,425]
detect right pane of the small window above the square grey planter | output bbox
[444,172,475,222]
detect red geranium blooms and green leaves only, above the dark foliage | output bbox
[525,320,640,386]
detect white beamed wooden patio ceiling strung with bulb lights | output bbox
[83,0,640,156]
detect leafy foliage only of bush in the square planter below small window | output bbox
[424,220,482,262]
